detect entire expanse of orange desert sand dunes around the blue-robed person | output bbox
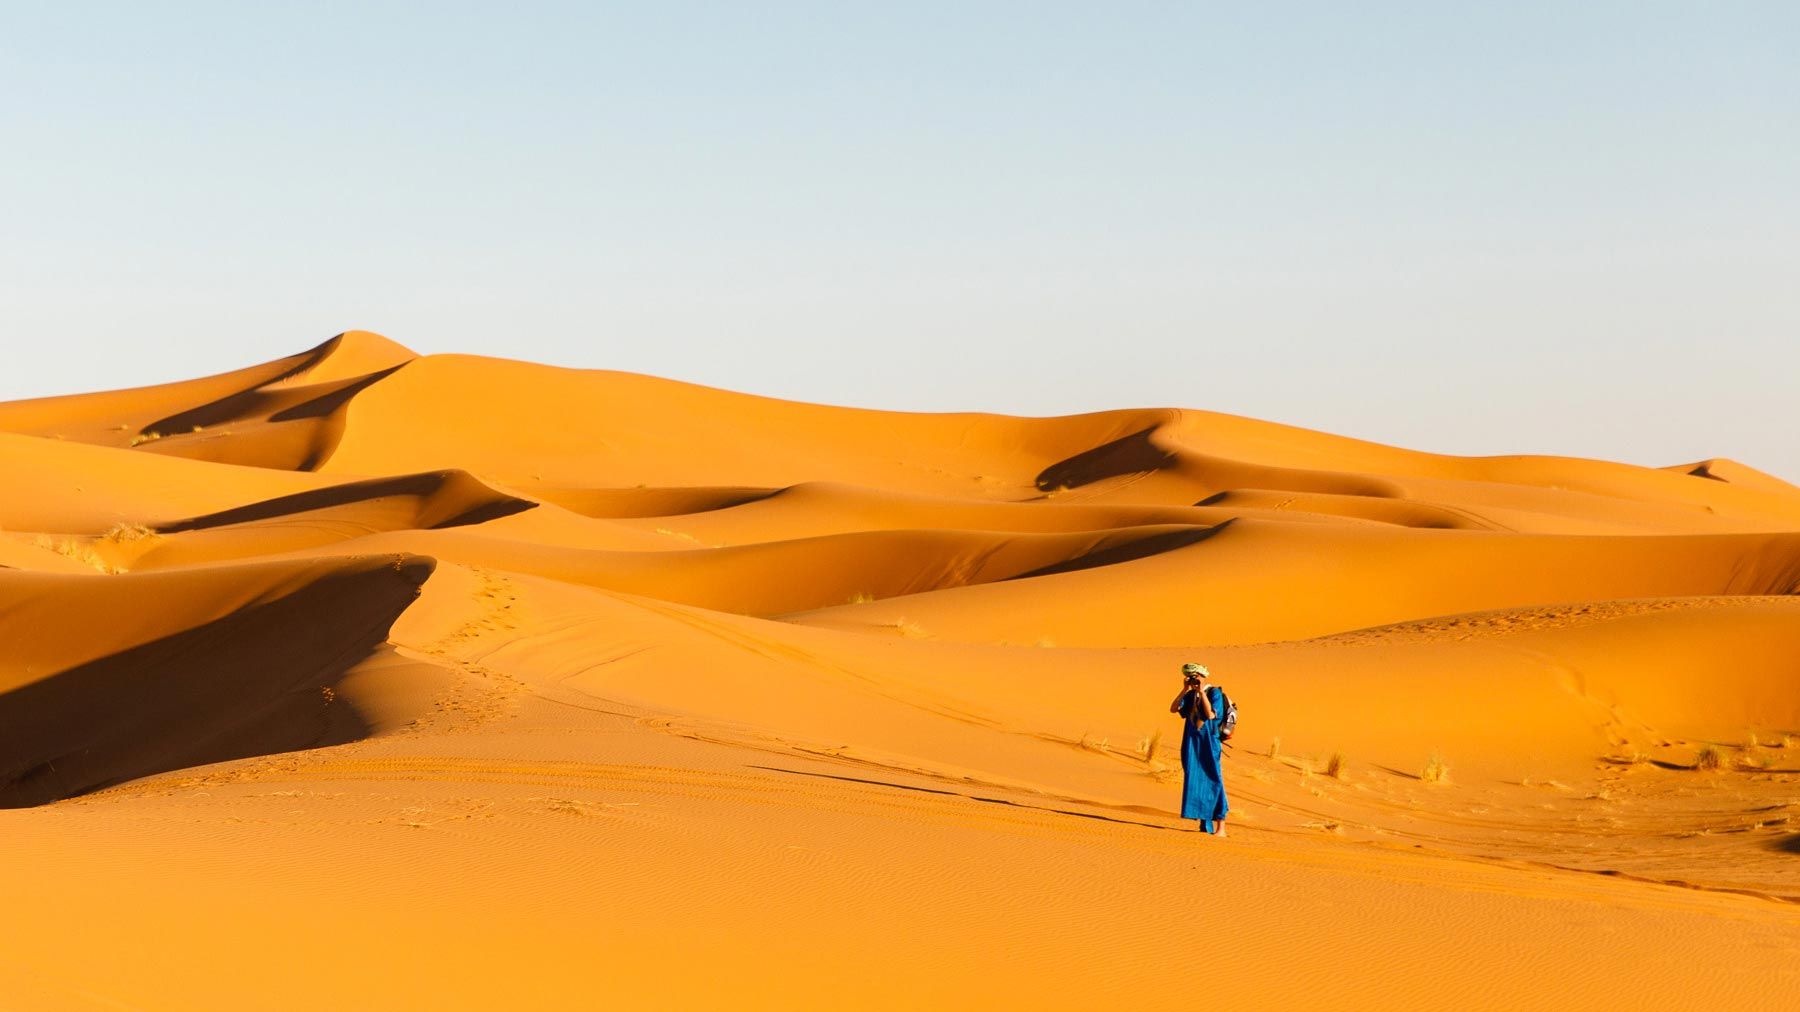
[0,331,1800,1010]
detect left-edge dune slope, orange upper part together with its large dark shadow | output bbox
[0,558,432,807]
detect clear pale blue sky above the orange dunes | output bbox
[0,0,1800,479]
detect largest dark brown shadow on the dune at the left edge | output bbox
[0,558,436,809]
